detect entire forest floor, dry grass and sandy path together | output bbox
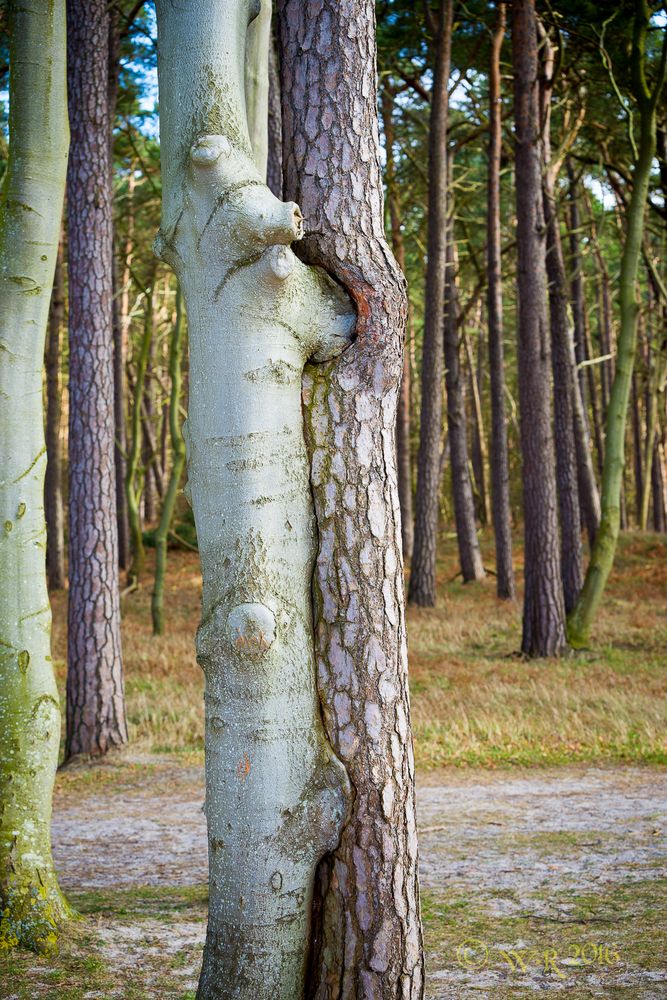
[0,535,667,1000]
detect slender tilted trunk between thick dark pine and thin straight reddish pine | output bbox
[444,218,484,583]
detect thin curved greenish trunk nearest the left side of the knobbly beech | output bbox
[151,288,186,635]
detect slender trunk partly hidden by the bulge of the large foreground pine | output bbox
[380,86,414,560]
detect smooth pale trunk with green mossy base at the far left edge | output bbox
[0,0,70,950]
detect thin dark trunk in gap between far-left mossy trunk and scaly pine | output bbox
[44,245,65,590]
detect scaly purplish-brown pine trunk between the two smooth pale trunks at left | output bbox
[65,0,127,757]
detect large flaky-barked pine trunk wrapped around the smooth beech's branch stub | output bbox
[278,0,426,1000]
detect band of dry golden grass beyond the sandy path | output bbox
[53,534,667,767]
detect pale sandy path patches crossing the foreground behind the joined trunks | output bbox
[47,762,667,1000]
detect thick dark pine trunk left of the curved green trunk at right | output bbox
[512,0,566,656]
